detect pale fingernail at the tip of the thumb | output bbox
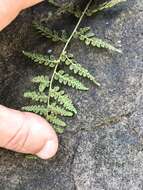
[36,140,57,160]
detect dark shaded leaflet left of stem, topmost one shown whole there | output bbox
[34,23,68,43]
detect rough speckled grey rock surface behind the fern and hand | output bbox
[0,0,143,190]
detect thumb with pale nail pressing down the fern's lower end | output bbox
[0,105,58,159]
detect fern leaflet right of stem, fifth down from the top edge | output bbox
[51,87,77,114]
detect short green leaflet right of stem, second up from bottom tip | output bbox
[46,114,66,127]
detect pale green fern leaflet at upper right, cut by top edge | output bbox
[86,0,126,16]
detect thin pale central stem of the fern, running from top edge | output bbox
[47,0,92,113]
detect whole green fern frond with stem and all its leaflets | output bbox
[23,0,125,133]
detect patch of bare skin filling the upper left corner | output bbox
[0,0,43,31]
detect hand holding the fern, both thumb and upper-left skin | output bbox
[0,0,58,159]
